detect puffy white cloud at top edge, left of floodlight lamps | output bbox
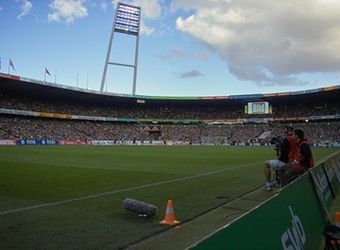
[48,0,87,23]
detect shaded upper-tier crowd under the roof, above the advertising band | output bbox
[0,93,340,120]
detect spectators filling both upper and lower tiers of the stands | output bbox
[0,92,340,144]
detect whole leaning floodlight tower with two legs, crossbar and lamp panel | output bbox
[100,2,141,95]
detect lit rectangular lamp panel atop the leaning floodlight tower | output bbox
[114,3,141,36]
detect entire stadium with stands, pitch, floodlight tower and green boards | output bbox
[0,0,340,249]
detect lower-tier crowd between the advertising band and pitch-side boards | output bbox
[0,116,340,145]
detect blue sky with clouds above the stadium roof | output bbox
[0,0,340,96]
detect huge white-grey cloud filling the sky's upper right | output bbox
[171,0,340,85]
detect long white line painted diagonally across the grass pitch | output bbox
[0,162,260,216]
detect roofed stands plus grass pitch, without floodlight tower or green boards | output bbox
[0,71,340,249]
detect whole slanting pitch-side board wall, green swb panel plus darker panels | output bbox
[192,151,340,250]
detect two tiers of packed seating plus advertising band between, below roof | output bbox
[0,77,340,146]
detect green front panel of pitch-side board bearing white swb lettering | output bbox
[193,174,325,250]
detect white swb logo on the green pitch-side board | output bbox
[281,206,306,250]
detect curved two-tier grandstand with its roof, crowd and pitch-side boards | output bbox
[1,72,340,147]
